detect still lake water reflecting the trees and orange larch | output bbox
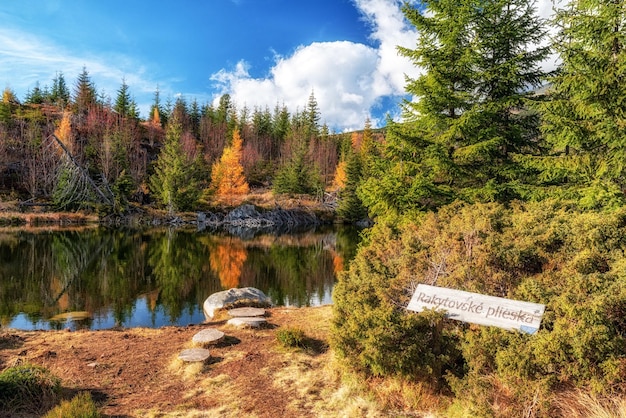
[0,227,359,330]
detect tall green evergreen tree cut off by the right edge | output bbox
[540,0,626,206]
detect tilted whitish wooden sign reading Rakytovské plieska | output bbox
[407,284,545,334]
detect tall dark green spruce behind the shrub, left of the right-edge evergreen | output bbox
[363,0,549,219]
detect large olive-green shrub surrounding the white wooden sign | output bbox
[331,202,626,417]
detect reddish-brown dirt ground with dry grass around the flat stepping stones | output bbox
[0,306,386,418]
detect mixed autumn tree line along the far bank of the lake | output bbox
[0,68,370,217]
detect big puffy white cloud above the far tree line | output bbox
[211,0,417,130]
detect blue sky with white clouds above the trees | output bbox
[0,0,552,132]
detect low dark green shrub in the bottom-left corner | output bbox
[0,364,61,414]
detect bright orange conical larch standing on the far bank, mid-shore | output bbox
[211,129,250,197]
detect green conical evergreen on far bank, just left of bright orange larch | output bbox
[150,113,200,213]
